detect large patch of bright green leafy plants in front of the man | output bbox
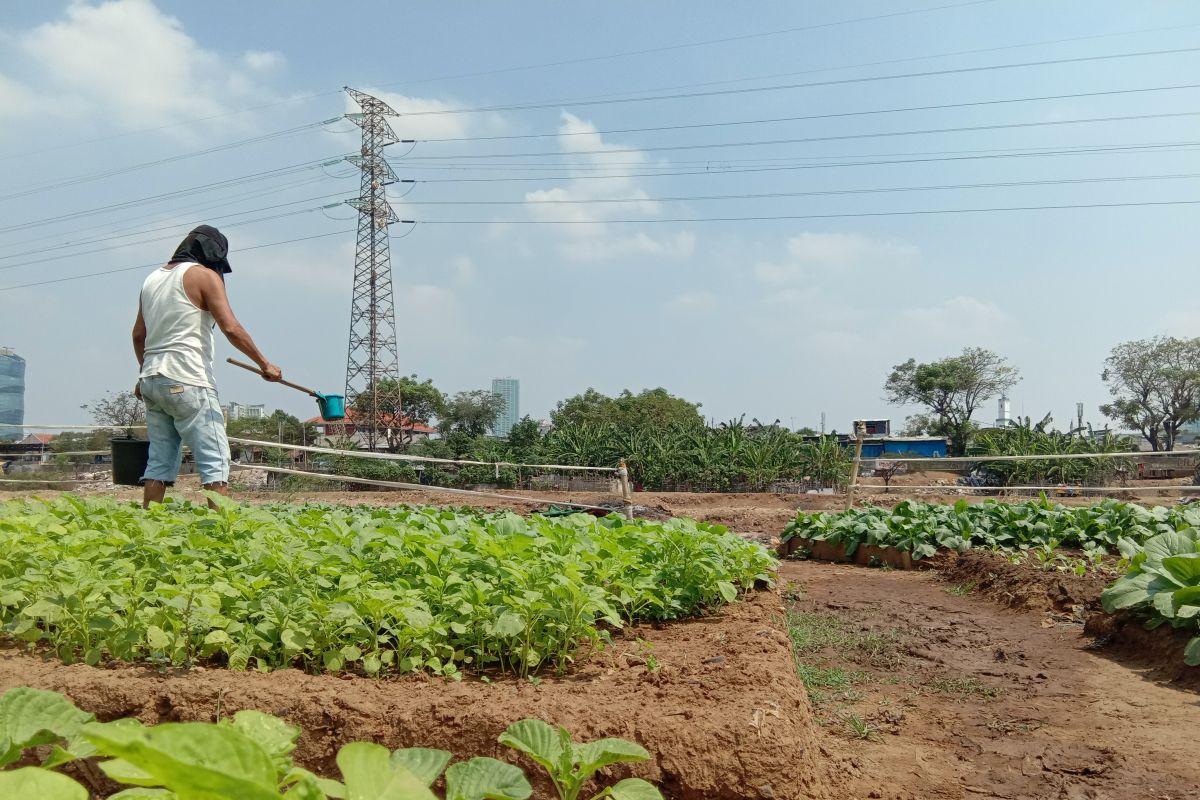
[0,495,774,675]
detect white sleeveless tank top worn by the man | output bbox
[142,264,216,389]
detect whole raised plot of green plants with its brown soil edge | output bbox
[0,497,826,800]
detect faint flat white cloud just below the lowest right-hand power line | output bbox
[754,231,920,285]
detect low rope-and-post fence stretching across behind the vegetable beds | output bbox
[0,425,1200,510]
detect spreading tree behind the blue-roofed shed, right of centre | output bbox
[883,348,1020,456]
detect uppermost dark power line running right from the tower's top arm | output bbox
[404,47,1200,116]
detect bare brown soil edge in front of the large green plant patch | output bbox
[0,591,828,800]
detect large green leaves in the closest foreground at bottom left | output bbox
[0,688,661,800]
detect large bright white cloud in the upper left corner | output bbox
[10,0,281,136]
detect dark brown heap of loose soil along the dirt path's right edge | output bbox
[929,551,1114,620]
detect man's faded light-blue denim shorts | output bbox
[139,375,229,485]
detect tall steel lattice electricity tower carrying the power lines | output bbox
[346,86,400,450]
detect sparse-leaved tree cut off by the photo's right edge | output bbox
[1100,336,1200,450]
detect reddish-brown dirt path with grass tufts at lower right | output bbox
[781,561,1200,800]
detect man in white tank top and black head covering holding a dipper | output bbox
[133,225,283,509]
